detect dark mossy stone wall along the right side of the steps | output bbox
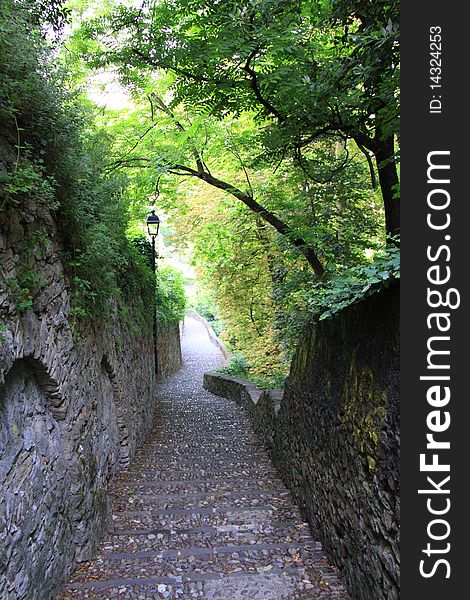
[205,285,399,600]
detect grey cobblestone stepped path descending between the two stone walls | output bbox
[59,318,349,600]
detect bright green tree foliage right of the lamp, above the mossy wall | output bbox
[61,0,398,378]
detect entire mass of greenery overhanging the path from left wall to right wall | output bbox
[0,0,399,384]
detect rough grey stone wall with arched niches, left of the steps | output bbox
[0,203,155,600]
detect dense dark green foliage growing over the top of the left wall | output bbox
[0,0,155,335]
